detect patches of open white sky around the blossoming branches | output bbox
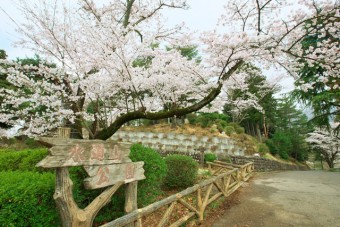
[0,0,293,93]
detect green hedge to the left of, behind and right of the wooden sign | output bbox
[0,144,166,226]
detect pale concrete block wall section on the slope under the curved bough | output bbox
[110,131,245,156]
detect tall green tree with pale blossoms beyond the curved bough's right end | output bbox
[224,63,277,137]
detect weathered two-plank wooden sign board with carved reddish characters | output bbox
[36,137,145,189]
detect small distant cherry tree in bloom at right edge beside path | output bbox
[306,124,340,168]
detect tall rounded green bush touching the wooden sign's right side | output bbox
[130,144,167,207]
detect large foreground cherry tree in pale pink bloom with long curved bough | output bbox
[0,0,339,139]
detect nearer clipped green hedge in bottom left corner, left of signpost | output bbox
[0,171,60,226]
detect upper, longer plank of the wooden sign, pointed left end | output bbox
[36,138,130,168]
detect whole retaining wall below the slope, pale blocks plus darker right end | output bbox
[110,131,307,171]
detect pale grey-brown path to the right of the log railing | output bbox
[212,171,340,227]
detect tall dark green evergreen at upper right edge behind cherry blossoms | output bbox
[293,8,340,127]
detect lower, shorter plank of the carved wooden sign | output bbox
[84,162,145,189]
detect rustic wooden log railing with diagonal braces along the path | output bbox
[102,161,254,227]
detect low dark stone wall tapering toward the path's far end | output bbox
[230,156,308,171]
